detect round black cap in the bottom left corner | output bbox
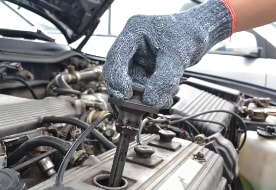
[0,168,26,190]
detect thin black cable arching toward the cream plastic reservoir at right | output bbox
[170,110,247,150]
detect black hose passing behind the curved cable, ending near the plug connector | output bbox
[42,116,116,150]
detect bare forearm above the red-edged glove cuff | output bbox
[228,0,276,32]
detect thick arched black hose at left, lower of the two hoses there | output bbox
[7,136,71,166]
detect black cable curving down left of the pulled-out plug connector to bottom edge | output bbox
[54,113,112,187]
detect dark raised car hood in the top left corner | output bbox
[7,0,113,44]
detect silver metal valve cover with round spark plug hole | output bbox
[30,135,226,190]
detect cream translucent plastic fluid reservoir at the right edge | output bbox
[239,126,276,190]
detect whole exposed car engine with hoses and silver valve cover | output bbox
[0,37,274,190]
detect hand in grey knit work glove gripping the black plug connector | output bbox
[103,0,234,108]
